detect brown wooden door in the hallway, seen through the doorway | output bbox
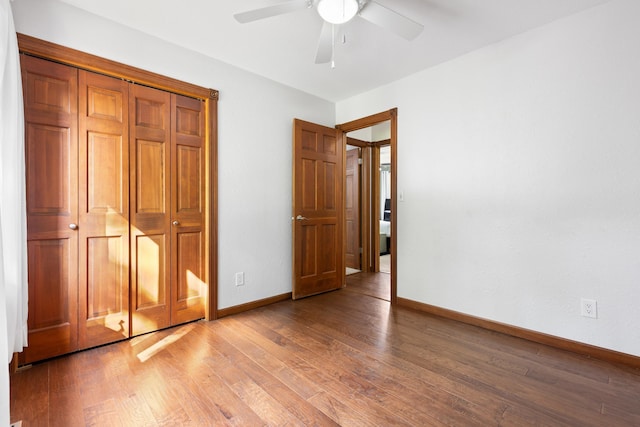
[344,148,362,270]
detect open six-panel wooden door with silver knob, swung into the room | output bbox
[292,119,345,299]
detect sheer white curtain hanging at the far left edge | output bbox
[0,0,28,425]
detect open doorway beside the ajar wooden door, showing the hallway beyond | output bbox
[336,109,397,303]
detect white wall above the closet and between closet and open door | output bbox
[12,0,335,308]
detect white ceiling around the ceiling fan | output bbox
[57,0,609,101]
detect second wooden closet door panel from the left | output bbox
[78,70,129,349]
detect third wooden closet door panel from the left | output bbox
[129,84,171,335]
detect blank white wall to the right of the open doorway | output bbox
[336,0,640,356]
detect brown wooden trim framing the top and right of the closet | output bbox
[17,33,219,320]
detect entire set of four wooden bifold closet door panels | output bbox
[20,55,206,364]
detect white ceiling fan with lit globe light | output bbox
[233,0,424,67]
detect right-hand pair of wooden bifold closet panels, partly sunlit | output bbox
[130,85,206,335]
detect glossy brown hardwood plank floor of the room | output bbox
[11,287,640,426]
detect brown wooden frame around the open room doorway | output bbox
[336,108,398,304]
